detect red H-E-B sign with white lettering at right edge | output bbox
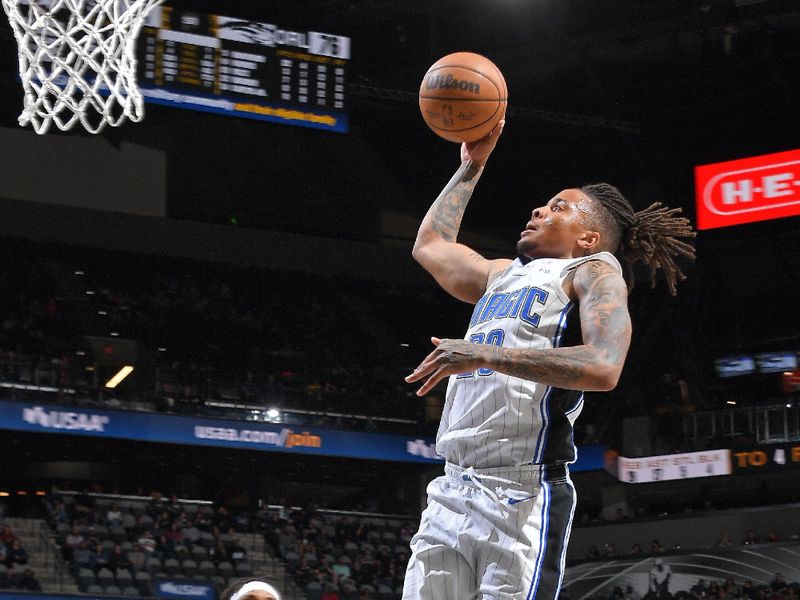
[694,150,800,229]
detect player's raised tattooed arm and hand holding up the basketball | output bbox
[413,121,511,304]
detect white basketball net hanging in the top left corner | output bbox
[2,0,162,133]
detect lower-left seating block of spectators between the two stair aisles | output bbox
[46,490,253,596]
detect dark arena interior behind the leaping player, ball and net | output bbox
[0,0,800,600]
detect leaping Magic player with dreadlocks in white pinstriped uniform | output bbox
[403,121,694,600]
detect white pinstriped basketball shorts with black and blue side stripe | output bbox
[403,463,576,600]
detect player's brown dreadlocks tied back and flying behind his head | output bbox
[581,183,696,296]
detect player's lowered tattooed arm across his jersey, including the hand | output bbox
[406,260,631,396]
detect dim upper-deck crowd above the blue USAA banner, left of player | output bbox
[0,239,468,432]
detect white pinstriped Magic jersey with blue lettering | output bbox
[436,252,622,469]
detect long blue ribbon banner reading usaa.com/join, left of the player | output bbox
[0,401,442,464]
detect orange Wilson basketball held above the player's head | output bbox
[419,52,508,142]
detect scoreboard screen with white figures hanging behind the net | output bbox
[137,6,350,132]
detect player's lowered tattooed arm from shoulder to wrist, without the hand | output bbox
[486,261,631,390]
